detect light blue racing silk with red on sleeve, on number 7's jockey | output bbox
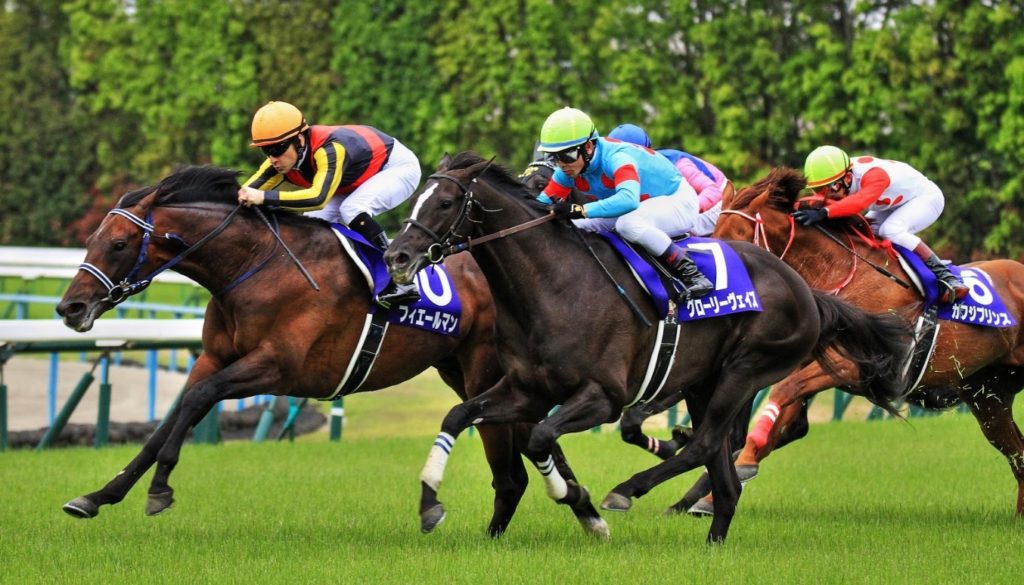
[538,138,683,217]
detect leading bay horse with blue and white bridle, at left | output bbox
[57,167,597,535]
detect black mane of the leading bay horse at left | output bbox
[118,166,240,208]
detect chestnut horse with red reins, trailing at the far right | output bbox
[715,168,1024,515]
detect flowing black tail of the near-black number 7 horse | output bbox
[813,291,911,415]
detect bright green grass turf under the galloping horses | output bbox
[0,411,1024,584]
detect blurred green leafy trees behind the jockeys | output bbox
[0,0,1024,261]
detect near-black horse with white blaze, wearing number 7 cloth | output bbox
[385,153,907,542]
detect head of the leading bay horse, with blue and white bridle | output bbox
[56,167,239,331]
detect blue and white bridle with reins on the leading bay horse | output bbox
[78,205,241,305]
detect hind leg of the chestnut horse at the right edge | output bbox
[961,367,1024,516]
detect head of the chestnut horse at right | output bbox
[712,167,806,243]
